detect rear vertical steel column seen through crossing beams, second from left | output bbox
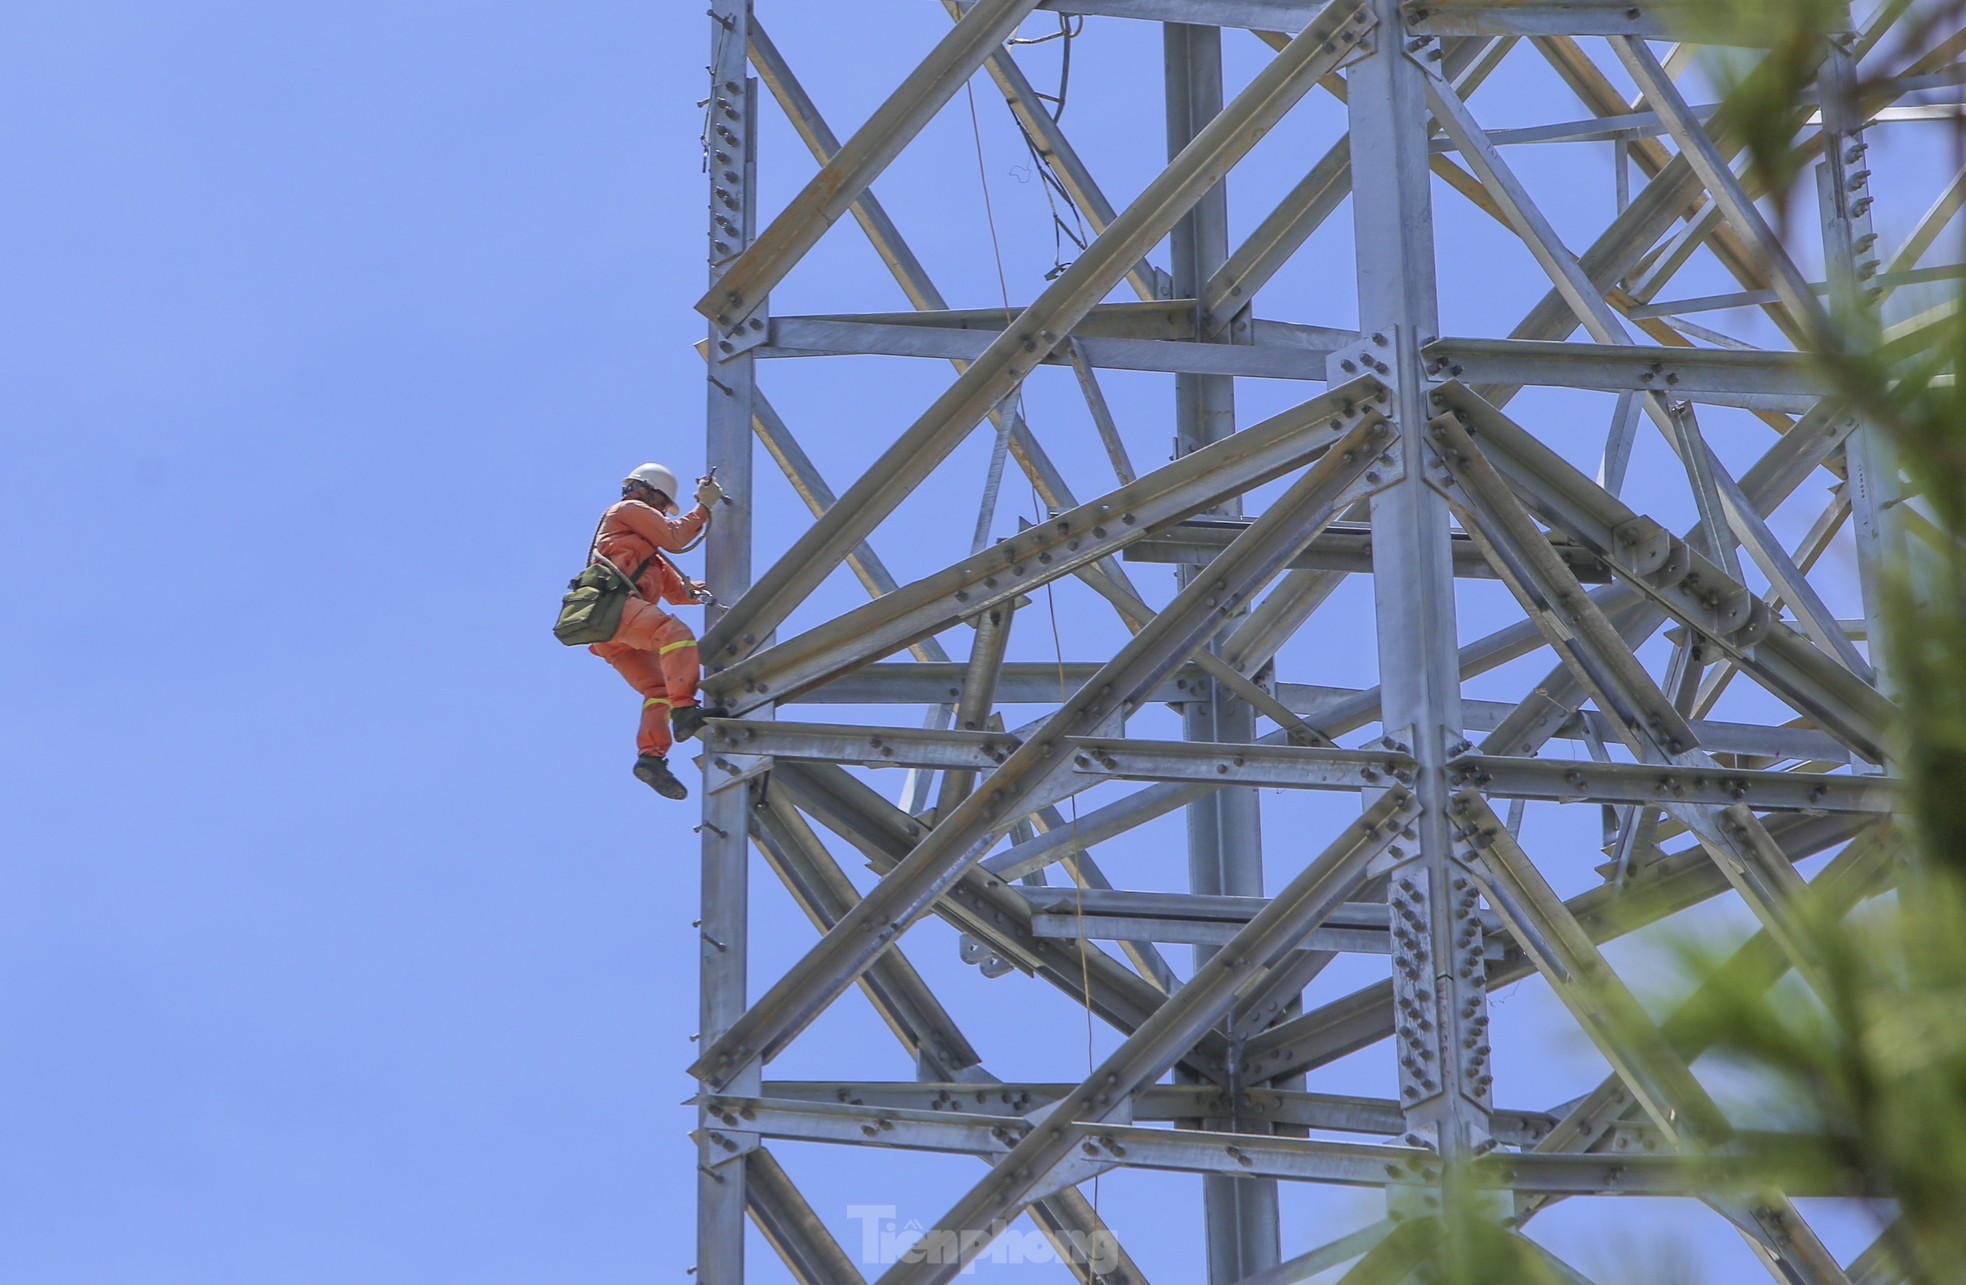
[1162,22,1282,1285]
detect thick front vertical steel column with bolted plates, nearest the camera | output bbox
[1349,0,1490,1178]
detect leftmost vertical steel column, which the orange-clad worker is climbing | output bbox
[696,0,769,1285]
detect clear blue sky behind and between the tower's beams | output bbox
[0,0,1937,1285]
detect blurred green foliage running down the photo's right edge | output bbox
[1635,0,1966,1285]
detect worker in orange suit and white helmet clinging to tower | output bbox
[588,464,723,798]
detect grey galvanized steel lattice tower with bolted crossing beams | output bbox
[676,0,1966,1285]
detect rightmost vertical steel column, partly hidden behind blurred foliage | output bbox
[1817,35,1909,692]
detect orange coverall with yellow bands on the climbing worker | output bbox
[588,499,710,758]
